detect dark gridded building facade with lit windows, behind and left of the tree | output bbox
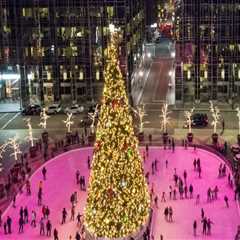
[0,0,145,105]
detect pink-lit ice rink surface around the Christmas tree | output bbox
[0,147,240,240]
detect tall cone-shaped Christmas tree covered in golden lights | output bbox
[85,33,150,238]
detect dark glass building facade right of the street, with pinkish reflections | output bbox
[175,0,240,104]
